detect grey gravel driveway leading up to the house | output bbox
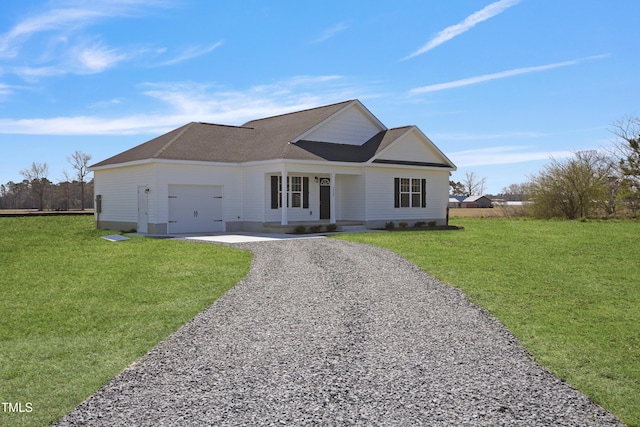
[59,239,622,426]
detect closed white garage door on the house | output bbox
[168,185,224,233]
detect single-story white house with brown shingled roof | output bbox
[90,100,456,234]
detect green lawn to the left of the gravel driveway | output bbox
[0,217,251,426]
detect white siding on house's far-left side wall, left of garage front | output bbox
[94,164,154,224]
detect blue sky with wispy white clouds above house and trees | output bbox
[0,0,640,193]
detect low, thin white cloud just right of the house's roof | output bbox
[447,146,573,168]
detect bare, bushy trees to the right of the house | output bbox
[450,116,640,219]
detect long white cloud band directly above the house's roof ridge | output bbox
[0,76,370,135]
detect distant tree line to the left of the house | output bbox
[0,150,93,211]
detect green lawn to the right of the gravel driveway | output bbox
[342,218,640,426]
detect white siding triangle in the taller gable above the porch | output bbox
[303,107,382,145]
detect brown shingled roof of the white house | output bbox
[91,100,455,169]
